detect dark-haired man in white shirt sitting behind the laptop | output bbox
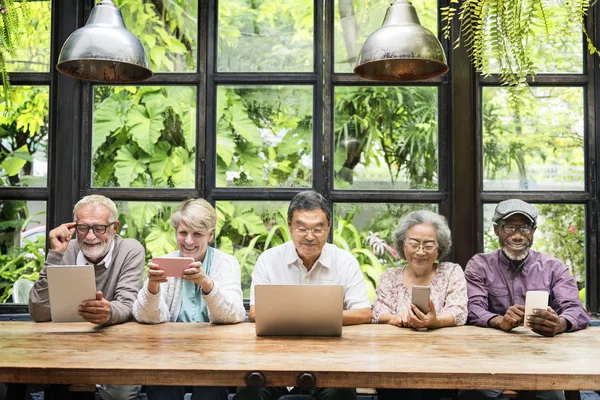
[234,191,371,400]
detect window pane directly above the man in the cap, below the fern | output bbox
[483,87,585,190]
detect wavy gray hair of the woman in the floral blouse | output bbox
[392,210,452,260]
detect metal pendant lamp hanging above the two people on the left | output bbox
[56,0,152,83]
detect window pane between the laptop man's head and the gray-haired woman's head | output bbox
[333,203,438,301]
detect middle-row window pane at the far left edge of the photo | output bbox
[0,85,49,187]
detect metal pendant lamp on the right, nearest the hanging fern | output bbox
[354,0,448,81]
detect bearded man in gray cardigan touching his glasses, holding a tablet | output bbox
[29,195,145,399]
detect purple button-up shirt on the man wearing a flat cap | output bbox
[465,250,590,331]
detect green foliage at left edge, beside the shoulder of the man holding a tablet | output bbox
[0,237,46,303]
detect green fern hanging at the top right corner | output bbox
[441,0,600,104]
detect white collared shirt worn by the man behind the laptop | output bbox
[250,241,371,310]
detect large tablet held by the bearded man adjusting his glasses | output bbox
[46,265,96,322]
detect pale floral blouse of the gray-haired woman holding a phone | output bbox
[372,262,468,325]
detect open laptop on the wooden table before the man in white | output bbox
[254,285,344,336]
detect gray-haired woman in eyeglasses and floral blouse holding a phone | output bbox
[373,210,467,400]
